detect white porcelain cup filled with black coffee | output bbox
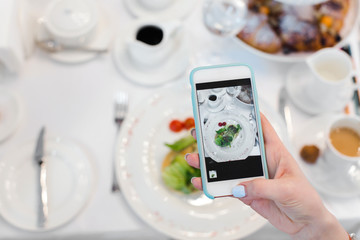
[127,21,182,67]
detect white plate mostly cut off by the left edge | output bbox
[0,88,22,142]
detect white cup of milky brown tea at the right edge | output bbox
[324,115,360,171]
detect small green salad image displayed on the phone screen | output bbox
[215,122,242,147]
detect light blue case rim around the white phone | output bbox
[190,63,269,199]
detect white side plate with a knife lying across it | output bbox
[0,138,95,231]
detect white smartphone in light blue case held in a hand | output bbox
[190,64,268,199]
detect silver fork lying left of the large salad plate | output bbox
[111,92,129,192]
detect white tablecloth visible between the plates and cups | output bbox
[0,0,360,240]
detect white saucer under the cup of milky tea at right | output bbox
[293,114,360,197]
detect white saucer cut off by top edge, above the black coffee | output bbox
[123,0,193,20]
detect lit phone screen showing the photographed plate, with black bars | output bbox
[195,78,264,182]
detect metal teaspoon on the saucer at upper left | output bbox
[36,39,108,54]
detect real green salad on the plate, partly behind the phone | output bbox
[162,135,200,194]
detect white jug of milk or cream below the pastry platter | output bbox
[302,48,357,110]
